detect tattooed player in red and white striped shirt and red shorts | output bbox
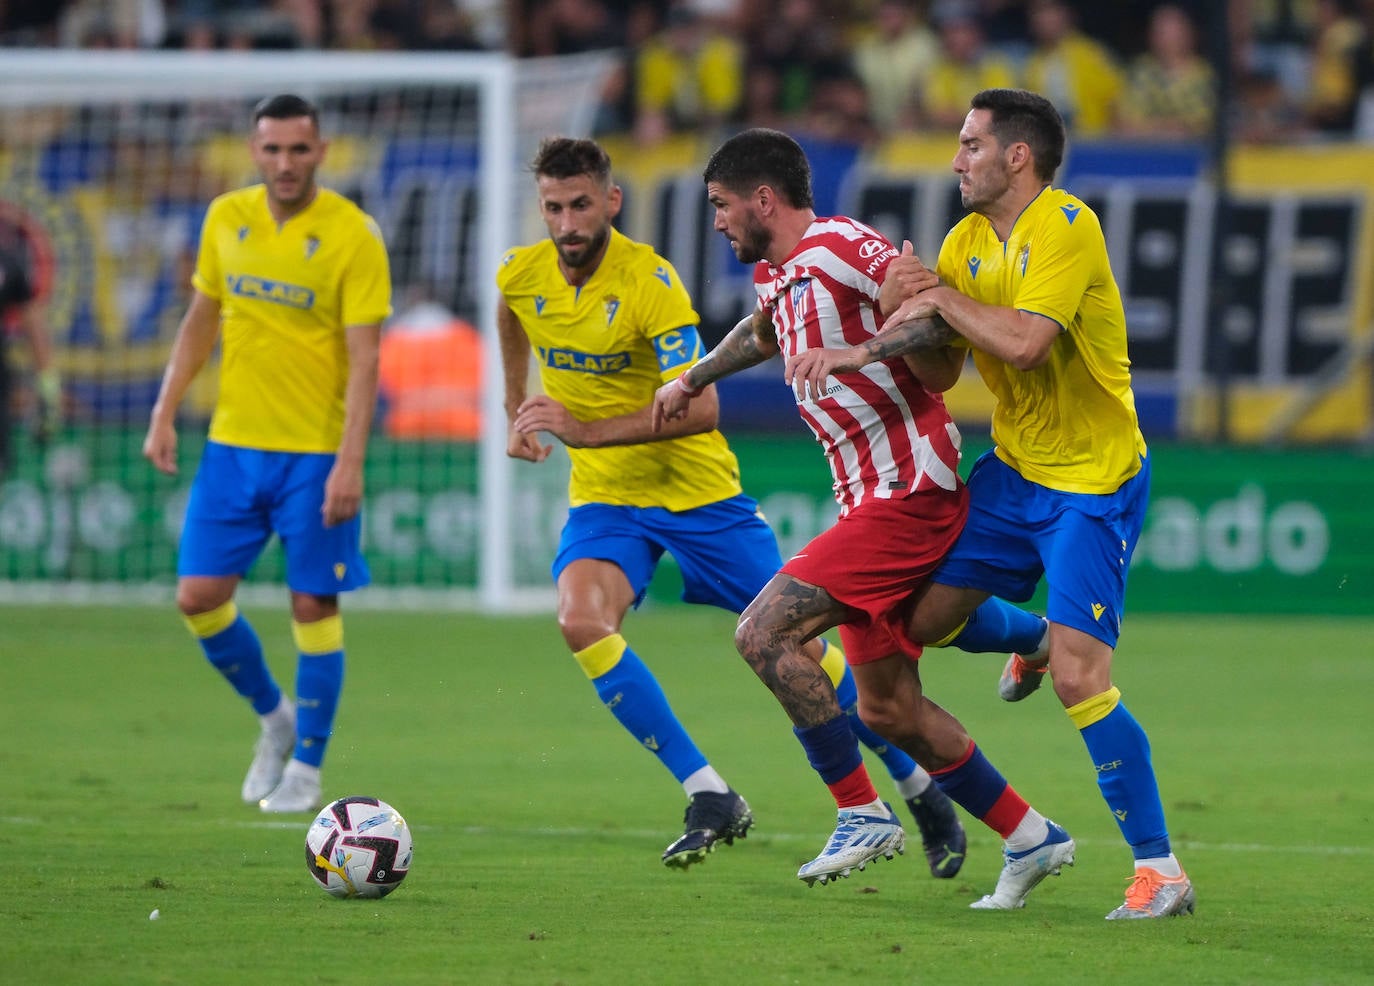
[654,129,1074,908]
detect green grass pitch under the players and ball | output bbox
[0,600,1374,986]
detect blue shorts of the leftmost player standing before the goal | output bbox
[177,442,368,596]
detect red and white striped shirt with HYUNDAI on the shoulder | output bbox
[754,216,959,514]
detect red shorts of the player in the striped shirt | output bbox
[782,483,969,665]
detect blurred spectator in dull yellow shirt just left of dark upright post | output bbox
[1121,4,1216,137]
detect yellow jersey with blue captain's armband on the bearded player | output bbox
[496,229,741,511]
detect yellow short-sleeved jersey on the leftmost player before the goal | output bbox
[191,185,392,452]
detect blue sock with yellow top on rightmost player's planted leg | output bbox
[1065,688,1172,860]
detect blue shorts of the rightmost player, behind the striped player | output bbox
[932,450,1150,647]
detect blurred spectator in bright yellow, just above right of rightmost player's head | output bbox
[1025,0,1121,137]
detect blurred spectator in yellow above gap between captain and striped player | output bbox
[635,4,745,144]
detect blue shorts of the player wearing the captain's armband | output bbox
[552,494,782,612]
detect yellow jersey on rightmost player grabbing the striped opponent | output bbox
[937,188,1146,493]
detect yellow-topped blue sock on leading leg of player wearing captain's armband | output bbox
[573,633,708,783]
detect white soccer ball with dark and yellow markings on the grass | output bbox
[305,796,411,897]
